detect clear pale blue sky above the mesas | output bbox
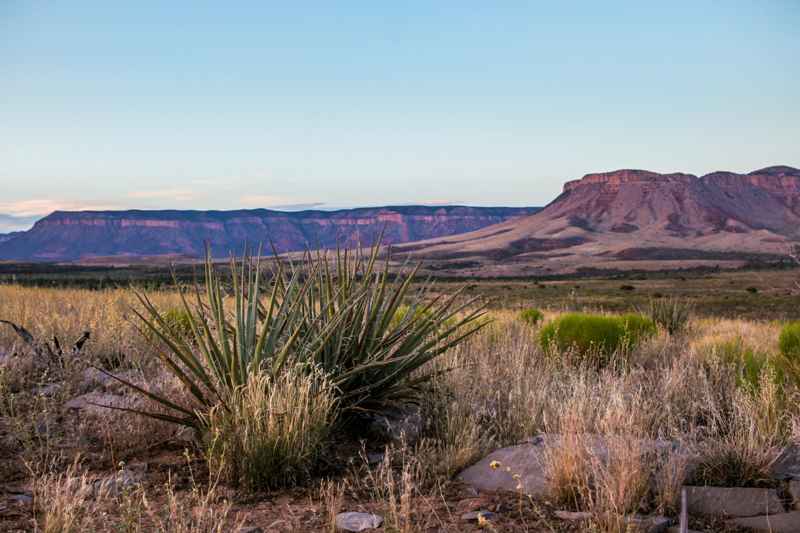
[0,0,800,232]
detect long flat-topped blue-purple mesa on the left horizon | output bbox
[0,206,536,261]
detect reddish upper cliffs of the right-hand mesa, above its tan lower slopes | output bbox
[552,167,800,236]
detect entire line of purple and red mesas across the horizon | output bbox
[0,166,800,276]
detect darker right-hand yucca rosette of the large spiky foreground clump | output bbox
[292,246,487,414]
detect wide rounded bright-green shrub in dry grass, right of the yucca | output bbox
[540,313,656,363]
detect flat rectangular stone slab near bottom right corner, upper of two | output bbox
[686,487,784,517]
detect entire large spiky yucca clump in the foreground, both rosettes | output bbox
[102,241,485,430]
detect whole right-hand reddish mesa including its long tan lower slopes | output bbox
[395,166,800,275]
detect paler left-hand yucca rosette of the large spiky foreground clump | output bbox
[101,254,335,429]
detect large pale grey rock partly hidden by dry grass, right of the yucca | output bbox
[458,434,673,498]
